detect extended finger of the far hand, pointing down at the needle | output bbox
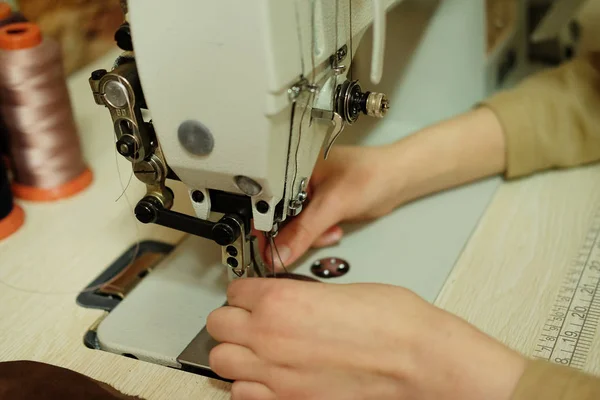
[264,188,342,267]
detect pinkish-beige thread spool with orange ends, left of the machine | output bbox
[0,23,92,201]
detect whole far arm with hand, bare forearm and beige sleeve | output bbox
[265,54,600,264]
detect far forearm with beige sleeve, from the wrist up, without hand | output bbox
[382,55,600,206]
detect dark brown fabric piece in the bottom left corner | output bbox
[0,361,141,400]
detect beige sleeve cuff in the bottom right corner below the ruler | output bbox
[511,361,600,400]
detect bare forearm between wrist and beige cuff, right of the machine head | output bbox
[383,107,506,205]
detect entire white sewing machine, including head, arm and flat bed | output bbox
[84,0,506,380]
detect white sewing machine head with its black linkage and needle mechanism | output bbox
[90,0,393,277]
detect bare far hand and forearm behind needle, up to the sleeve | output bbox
[264,107,506,265]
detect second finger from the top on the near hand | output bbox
[206,307,250,345]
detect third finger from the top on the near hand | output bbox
[208,343,267,382]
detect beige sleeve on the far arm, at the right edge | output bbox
[483,53,600,178]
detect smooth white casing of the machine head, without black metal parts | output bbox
[129,0,399,231]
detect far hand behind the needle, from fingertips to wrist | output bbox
[264,146,401,266]
